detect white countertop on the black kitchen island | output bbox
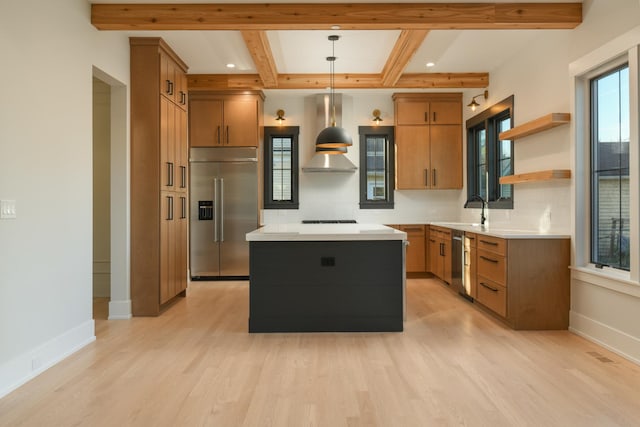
[246,223,407,242]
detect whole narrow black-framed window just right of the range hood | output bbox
[358,126,395,209]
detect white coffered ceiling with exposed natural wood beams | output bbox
[91,0,582,89]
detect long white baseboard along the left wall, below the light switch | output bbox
[0,319,96,398]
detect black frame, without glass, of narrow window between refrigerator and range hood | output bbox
[263,126,300,209]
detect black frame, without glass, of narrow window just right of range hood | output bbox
[358,126,395,209]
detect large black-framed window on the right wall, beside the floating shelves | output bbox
[590,64,630,271]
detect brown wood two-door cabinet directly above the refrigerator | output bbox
[189,91,264,147]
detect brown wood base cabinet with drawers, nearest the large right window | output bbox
[472,234,570,330]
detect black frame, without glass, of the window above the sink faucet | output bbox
[466,95,514,209]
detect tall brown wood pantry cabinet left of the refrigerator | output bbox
[130,37,189,316]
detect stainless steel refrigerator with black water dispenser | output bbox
[189,147,258,280]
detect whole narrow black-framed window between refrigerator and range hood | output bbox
[264,126,300,209]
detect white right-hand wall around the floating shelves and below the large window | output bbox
[461,0,640,363]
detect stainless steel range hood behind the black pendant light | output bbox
[302,94,358,173]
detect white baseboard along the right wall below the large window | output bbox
[569,311,640,365]
